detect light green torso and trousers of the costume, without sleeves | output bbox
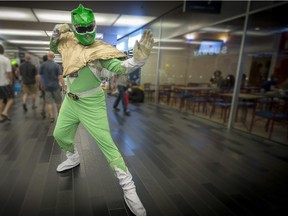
[54,66,126,172]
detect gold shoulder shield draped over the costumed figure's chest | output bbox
[58,32,127,76]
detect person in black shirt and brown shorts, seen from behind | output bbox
[20,54,37,112]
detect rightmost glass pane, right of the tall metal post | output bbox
[233,2,288,144]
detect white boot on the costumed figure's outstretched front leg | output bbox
[115,167,146,216]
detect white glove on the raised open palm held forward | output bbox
[133,30,154,62]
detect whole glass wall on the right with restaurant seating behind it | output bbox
[117,1,288,143]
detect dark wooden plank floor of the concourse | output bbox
[0,93,288,216]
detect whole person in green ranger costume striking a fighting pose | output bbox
[50,4,153,216]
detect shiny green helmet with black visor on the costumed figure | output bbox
[71,4,96,45]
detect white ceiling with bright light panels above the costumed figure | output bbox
[0,1,182,60]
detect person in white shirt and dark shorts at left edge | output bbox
[0,44,14,123]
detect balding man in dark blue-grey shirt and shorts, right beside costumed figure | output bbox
[39,51,66,123]
